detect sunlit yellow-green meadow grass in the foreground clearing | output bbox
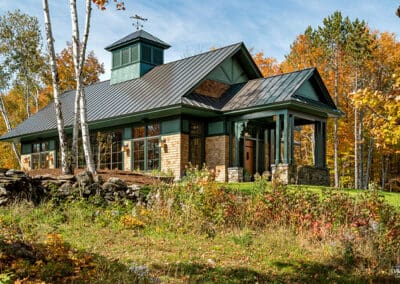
[0,202,376,283]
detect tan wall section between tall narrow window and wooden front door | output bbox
[205,135,229,182]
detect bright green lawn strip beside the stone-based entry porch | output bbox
[226,182,400,208]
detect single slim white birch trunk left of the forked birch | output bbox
[42,0,72,174]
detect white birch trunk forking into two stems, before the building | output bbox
[70,0,96,173]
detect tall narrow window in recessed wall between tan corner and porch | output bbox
[189,121,204,167]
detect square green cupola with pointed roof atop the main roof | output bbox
[105,30,170,84]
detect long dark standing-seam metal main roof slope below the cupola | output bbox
[0,43,245,140]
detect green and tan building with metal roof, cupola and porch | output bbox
[0,30,339,183]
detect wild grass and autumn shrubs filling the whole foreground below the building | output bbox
[0,171,400,283]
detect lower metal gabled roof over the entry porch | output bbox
[182,68,337,112]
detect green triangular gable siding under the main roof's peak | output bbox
[206,58,248,84]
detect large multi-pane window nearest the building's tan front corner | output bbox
[132,123,160,171]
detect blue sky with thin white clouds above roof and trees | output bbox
[0,0,400,80]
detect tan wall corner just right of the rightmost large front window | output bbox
[161,133,189,180]
